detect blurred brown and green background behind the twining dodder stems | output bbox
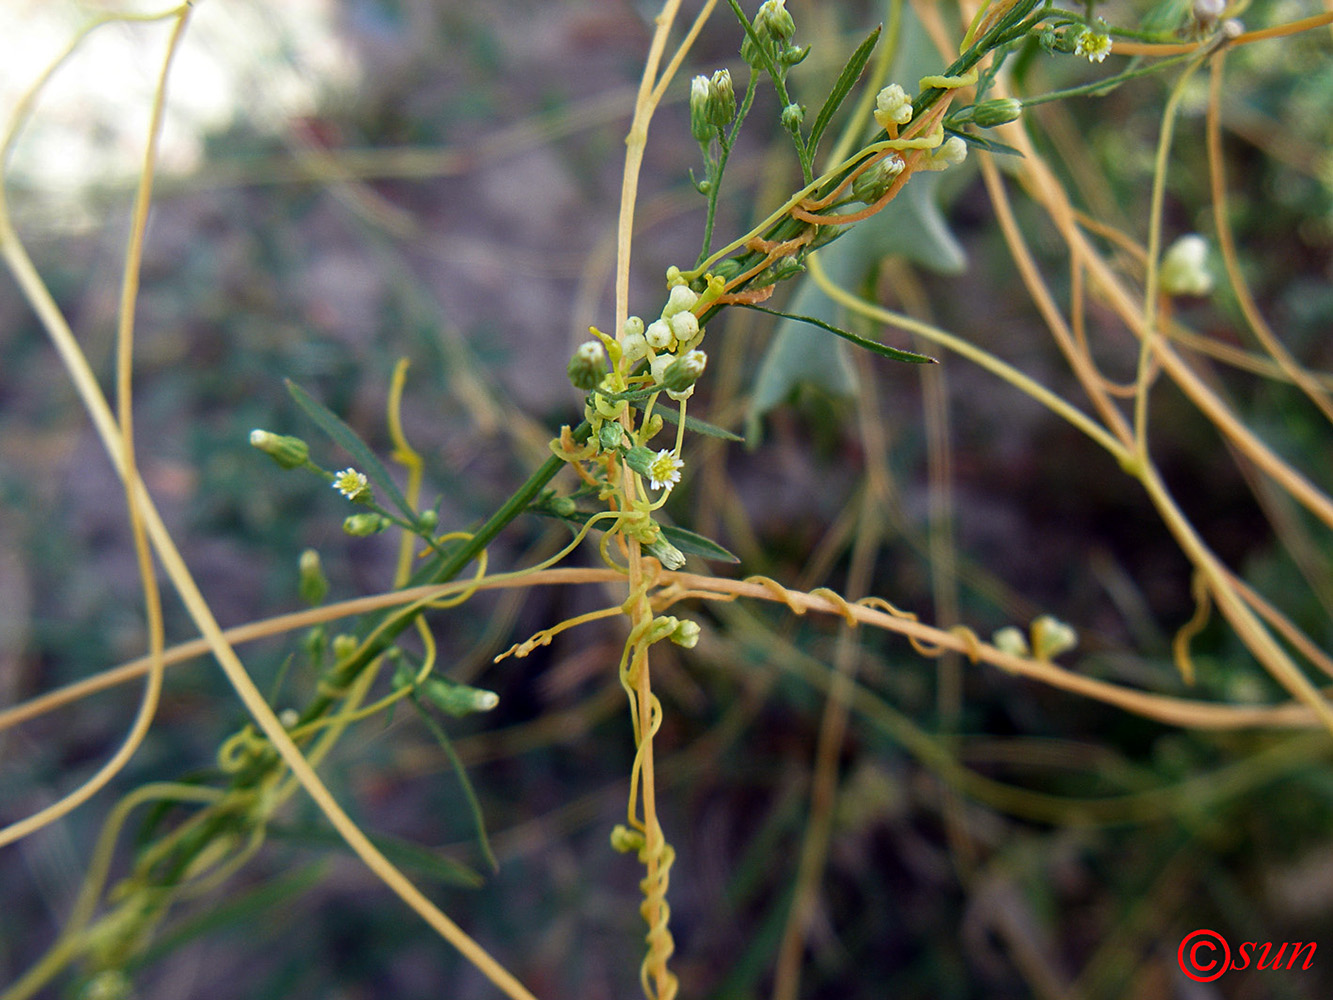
[0,0,1333,1000]
